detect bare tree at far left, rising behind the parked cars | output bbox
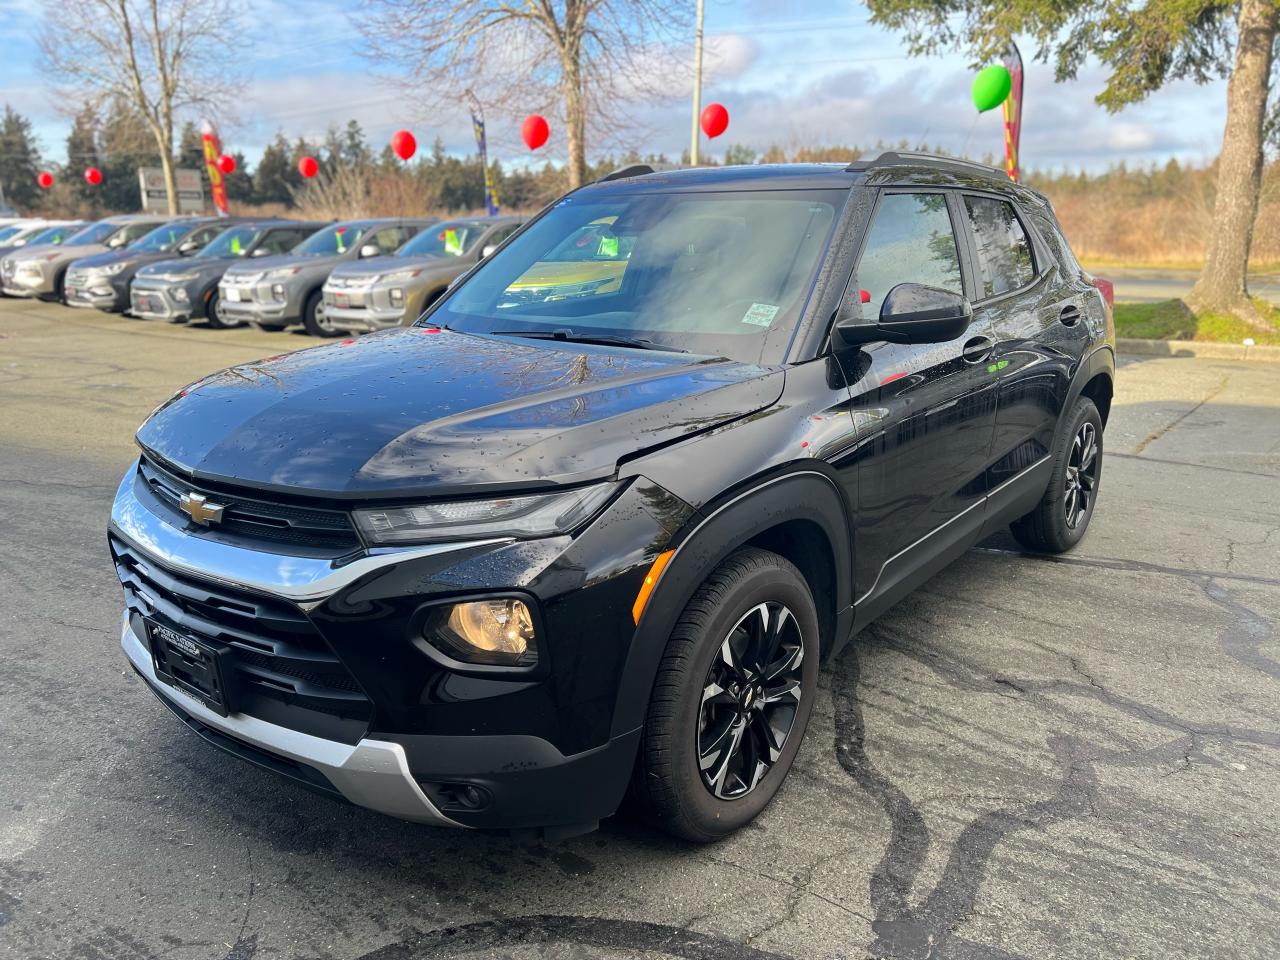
[40,0,239,214]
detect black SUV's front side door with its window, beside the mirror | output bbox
[850,189,996,616]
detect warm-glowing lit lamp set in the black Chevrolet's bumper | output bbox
[422,598,538,667]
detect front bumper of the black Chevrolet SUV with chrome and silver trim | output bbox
[110,471,680,835]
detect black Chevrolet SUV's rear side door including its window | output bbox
[960,193,1088,504]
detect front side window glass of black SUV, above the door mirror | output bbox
[854,193,964,316]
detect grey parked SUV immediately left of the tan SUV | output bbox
[218,218,433,337]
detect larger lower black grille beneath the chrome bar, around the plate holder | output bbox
[110,535,372,744]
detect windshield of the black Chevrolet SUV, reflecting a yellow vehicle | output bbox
[431,191,846,362]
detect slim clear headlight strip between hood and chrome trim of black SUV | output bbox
[356,483,617,544]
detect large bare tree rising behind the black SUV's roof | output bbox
[356,0,691,187]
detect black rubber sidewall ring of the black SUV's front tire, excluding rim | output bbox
[672,567,819,838]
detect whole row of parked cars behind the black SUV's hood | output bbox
[0,214,524,337]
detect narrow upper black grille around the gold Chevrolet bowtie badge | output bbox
[138,457,360,550]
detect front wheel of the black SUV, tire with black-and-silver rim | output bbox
[632,548,819,844]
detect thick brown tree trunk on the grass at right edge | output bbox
[1187,0,1276,332]
